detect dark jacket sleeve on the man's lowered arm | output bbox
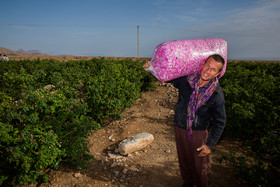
[206,91,226,149]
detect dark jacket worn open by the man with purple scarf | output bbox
[170,77,226,148]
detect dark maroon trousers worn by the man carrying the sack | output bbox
[175,125,211,187]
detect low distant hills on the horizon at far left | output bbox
[0,47,49,56]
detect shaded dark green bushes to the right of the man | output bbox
[220,62,280,184]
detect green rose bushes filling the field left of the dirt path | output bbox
[0,59,153,185]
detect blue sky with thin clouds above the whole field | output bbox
[0,0,280,59]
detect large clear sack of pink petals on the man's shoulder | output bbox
[148,38,227,82]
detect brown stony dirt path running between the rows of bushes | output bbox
[36,83,246,187]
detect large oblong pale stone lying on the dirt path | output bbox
[118,132,154,155]
